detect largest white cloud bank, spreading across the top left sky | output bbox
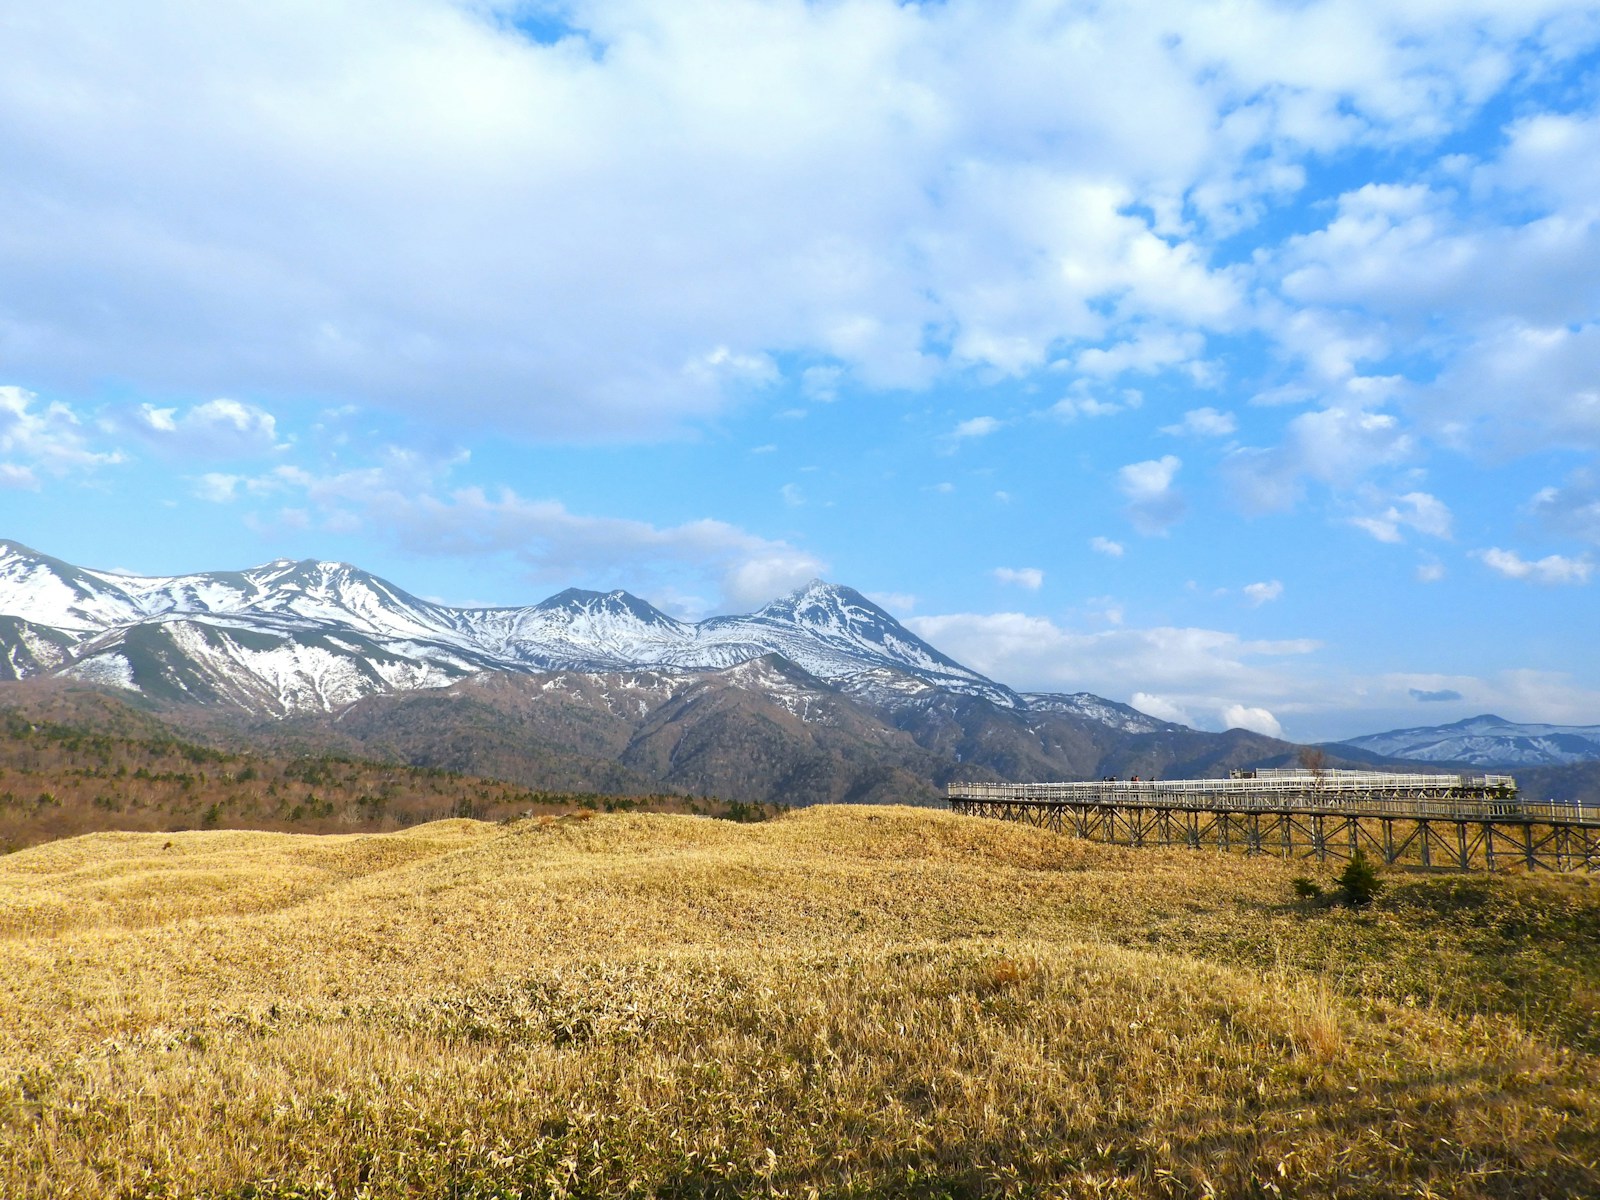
[0,0,1594,437]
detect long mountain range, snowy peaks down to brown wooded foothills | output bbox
[0,542,1593,803]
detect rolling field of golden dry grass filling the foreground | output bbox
[0,808,1600,1200]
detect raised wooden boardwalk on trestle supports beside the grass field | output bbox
[949,770,1600,872]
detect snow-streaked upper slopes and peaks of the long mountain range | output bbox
[0,542,1024,715]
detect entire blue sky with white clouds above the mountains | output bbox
[0,0,1600,739]
